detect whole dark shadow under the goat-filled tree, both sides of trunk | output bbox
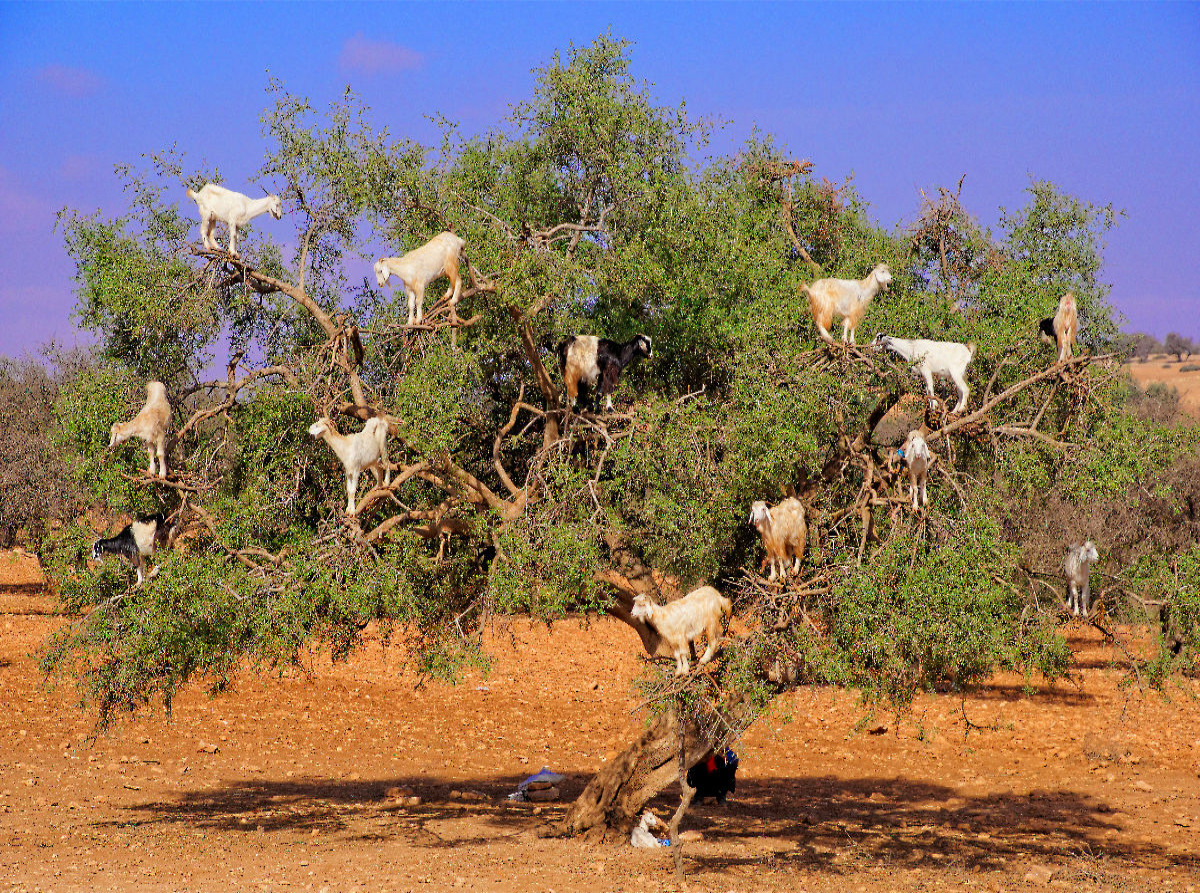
[114,775,1200,874]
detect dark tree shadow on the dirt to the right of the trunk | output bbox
[655,775,1200,874]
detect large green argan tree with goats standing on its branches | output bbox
[43,36,1198,849]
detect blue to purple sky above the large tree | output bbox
[0,2,1200,355]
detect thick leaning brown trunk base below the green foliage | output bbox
[541,712,709,838]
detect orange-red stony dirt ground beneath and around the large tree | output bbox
[0,555,1200,893]
